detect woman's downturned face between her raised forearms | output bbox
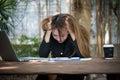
[52,28,68,43]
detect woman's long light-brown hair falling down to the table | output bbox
[42,14,90,57]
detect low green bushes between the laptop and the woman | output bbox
[12,35,41,57]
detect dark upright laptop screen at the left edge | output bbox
[0,31,19,61]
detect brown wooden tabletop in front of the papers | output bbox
[0,58,120,74]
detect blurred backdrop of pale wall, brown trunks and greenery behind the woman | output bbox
[0,0,120,57]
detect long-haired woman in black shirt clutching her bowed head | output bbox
[38,14,90,80]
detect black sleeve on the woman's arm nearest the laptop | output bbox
[39,35,50,58]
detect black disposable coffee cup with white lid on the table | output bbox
[103,44,114,58]
